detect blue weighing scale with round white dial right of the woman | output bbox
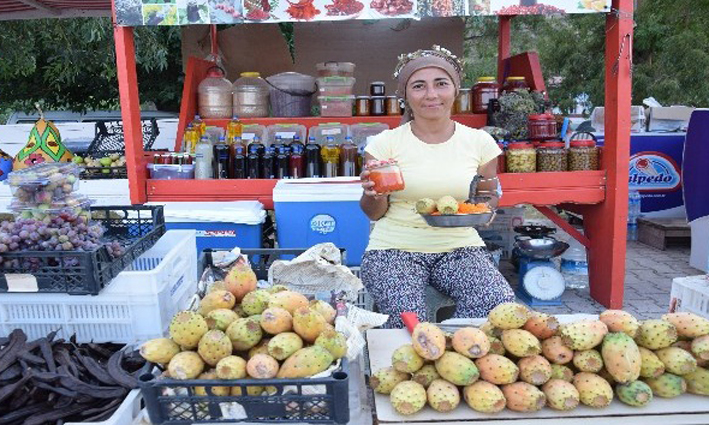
[512,225,569,307]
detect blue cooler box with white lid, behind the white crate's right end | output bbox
[156,201,266,255]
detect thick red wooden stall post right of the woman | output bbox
[584,0,633,308]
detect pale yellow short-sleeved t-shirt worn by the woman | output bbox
[365,123,502,253]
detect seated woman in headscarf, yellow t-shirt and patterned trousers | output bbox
[360,46,514,327]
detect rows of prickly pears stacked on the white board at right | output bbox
[369,303,709,415]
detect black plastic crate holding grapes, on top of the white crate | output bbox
[0,205,165,295]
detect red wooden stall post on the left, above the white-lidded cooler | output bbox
[111,2,148,204]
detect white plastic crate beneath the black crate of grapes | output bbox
[0,230,197,343]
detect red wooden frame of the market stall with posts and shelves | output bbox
[114,0,634,308]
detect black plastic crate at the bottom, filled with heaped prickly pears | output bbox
[139,359,350,425]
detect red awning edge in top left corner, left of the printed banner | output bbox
[0,0,111,21]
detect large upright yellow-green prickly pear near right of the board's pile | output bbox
[601,332,640,384]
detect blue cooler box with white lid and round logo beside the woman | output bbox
[273,177,370,266]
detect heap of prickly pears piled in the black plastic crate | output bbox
[140,255,347,395]
